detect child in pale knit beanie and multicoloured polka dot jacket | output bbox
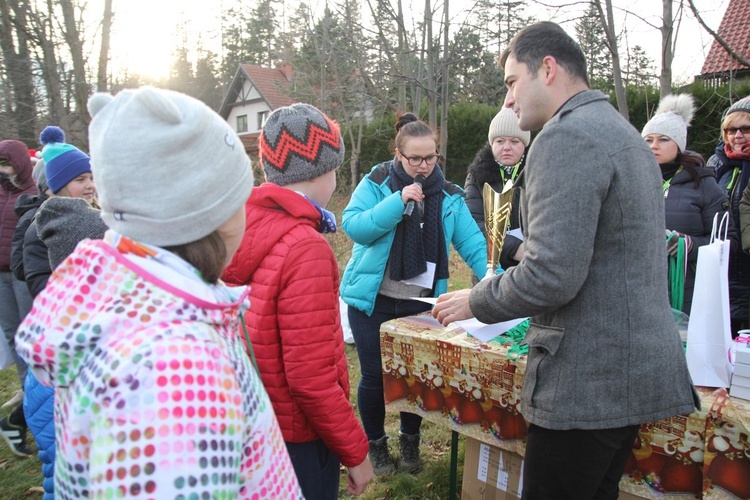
[17,87,302,499]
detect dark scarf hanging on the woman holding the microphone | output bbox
[388,159,448,286]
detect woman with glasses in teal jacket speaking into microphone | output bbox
[341,113,487,474]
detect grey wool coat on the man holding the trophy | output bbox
[469,90,700,430]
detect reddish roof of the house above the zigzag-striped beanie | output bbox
[219,64,295,120]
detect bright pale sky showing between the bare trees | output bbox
[100,0,729,83]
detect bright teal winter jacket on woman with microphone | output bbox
[341,162,487,315]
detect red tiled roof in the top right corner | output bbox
[701,0,750,76]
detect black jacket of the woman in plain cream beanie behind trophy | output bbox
[464,144,525,269]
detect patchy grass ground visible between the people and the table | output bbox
[0,189,478,500]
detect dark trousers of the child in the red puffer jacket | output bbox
[286,439,341,500]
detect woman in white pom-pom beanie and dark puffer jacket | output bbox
[641,94,727,314]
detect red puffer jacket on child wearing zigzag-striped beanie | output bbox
[223,183,368,467]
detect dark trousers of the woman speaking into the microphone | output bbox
[349,295,430,441]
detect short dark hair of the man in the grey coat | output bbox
[500,21,589,87]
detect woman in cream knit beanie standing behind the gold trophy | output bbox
[464,107,531,283]
